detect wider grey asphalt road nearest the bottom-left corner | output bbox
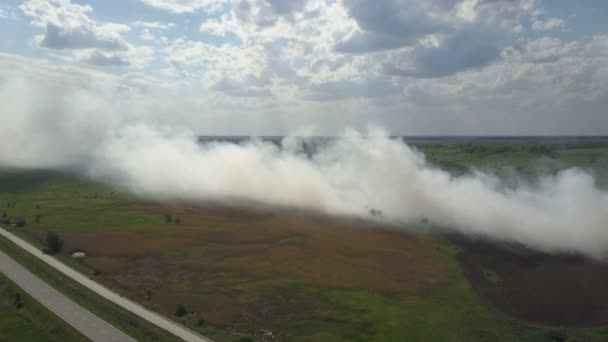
[0,251,135,342]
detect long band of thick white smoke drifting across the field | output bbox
[0,73,608,257]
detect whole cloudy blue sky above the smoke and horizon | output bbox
[0,0,608,135]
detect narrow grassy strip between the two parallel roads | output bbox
[0,237,180,341]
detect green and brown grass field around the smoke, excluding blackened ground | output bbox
[0,145,608,341]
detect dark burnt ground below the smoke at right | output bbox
[450,237,608,327]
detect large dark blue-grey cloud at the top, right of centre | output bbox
[336,0,534,77]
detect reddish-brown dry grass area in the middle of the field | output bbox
[32,205,449,330]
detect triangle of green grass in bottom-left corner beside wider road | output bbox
[0,274,88,342]
